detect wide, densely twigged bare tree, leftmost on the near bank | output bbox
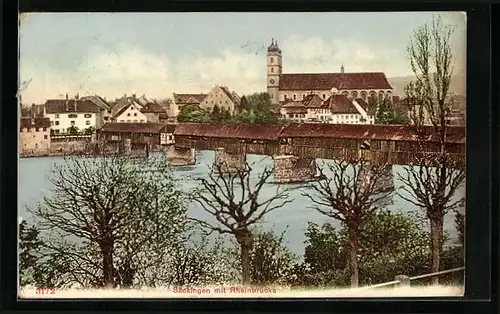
[29,155,187,288]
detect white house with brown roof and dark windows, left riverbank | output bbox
[44,96,103,134]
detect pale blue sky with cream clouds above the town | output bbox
[19,12,466,104]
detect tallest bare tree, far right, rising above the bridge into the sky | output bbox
[398,18,465,284]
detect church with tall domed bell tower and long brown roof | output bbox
[267,39,392,104]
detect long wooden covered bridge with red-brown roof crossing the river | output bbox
[167,123,465,181]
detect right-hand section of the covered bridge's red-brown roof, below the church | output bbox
[279,123,465,143]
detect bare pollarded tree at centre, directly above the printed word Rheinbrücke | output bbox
[192,163,292,285]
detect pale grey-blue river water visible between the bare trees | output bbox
[18,151,465,255]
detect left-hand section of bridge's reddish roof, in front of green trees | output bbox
[174,123,286,141]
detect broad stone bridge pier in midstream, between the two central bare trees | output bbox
[273,155,317,183]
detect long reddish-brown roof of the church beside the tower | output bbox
[279,72,392,90]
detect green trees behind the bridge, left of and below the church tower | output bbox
[177,93,278,124]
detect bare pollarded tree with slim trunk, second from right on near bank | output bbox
[302,159,392,287]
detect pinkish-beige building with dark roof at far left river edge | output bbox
[19,118,50,156]
